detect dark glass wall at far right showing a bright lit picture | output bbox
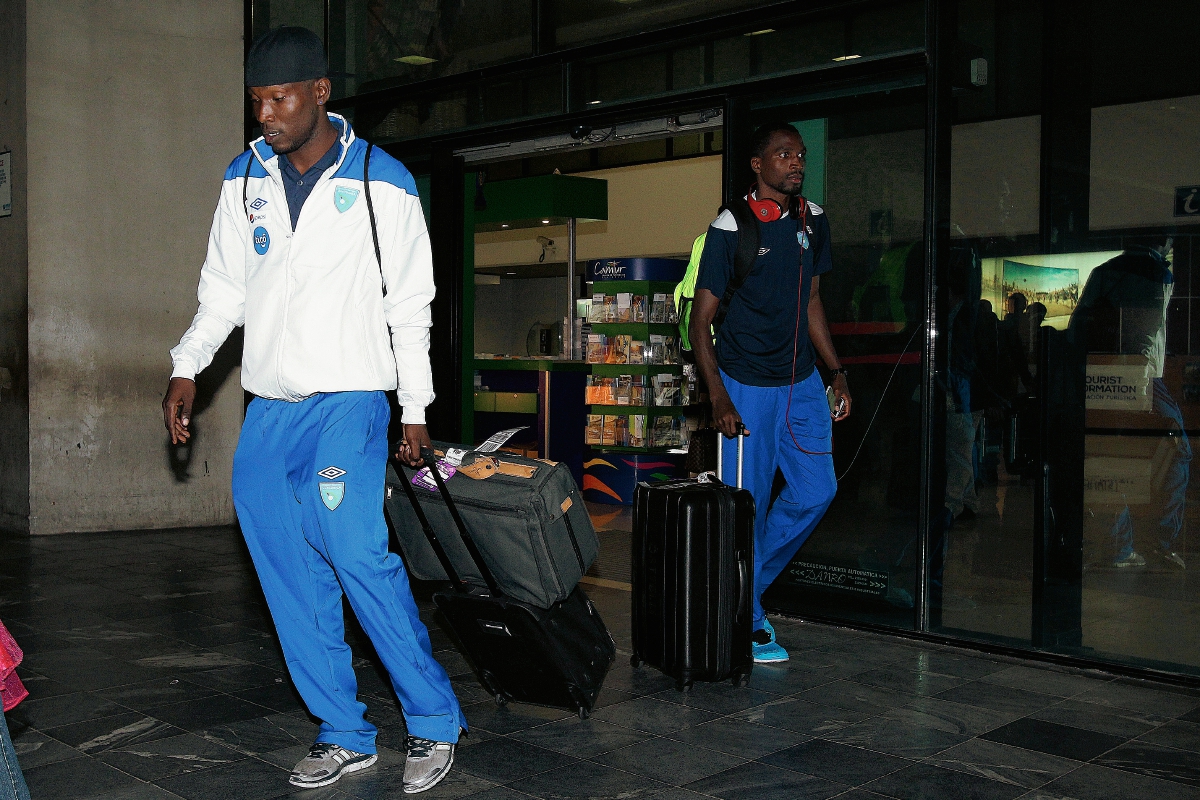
[929,0,1200,674]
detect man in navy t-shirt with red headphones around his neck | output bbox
[689,122,851,663]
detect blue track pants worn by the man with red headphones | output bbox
[721,371,838,628]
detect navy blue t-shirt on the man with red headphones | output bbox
[696,203,833,386]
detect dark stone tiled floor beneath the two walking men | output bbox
[0,529,1200,800]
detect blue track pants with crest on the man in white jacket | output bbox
[233,392,466,753]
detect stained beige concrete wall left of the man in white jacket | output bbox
[26,0,245,534]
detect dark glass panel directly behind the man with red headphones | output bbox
[758,89,925,628]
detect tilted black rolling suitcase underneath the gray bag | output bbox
[401,453,617,718]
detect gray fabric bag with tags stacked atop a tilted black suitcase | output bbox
[384,443,600,608]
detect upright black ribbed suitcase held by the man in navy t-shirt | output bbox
[630,435,755,691]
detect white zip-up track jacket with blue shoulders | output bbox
[170,114,434,425]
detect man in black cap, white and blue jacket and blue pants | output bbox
[163,28,466,793]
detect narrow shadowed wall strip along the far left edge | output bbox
[0,0,29,531]
